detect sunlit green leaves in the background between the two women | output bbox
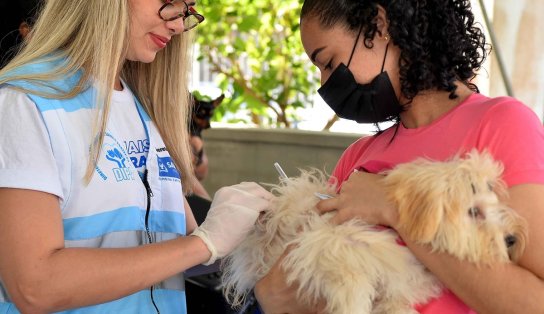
[196,0,318,127]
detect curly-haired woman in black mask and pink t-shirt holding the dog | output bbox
[255,0,544,314]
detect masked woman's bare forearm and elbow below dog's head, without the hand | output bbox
[401,184,544,314]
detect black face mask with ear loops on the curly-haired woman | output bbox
[317,28,402,123]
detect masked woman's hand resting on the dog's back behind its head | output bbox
[316,171,398,228]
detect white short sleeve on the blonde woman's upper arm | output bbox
[0,86,63,198]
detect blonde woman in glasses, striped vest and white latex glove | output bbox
[0,0,269,313]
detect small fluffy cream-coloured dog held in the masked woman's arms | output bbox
[222,151,526,314]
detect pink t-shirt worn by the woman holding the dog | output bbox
[333,94,544,314]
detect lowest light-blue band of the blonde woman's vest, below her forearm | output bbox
[0,290,187,314]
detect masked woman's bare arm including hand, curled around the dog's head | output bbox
[318,173,544,314]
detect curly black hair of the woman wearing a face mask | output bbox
[301,0,489,103]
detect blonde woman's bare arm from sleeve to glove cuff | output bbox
[0,188,210,313]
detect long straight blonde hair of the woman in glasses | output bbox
[0,0,196,192]
